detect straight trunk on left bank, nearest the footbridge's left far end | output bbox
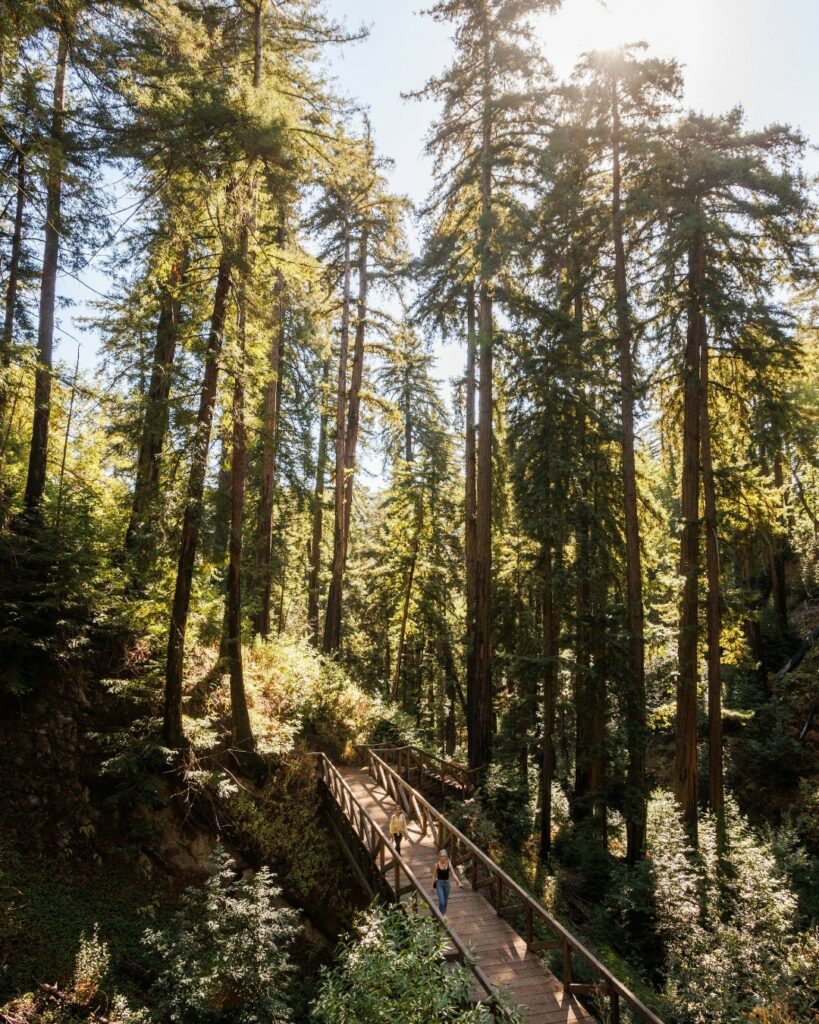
[224,288,254,751]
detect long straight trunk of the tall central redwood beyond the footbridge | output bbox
[469,8,494,772]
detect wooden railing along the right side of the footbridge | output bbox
[361,746,662,1024]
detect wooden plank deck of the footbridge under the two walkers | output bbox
[339,767,594,1024]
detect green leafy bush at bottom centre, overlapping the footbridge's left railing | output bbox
[312,907,518,1024]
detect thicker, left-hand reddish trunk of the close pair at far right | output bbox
[674,225,705,844]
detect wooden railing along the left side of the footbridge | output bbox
[312,753,516,1022]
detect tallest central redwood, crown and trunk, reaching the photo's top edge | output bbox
[417,0,559,771]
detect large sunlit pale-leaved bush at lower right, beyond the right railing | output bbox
[608,792,796,1024]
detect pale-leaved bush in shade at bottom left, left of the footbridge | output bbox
[143,847,296,1024]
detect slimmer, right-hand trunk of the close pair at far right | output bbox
[699,337,725,819]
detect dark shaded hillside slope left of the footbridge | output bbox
[0,652,364,1006]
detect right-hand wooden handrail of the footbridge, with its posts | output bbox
[362,745,662,1024]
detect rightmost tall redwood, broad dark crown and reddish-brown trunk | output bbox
[656,111,808,840]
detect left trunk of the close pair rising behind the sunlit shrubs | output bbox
[322,224,351,654]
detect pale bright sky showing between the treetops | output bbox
[57,0,819,379]
